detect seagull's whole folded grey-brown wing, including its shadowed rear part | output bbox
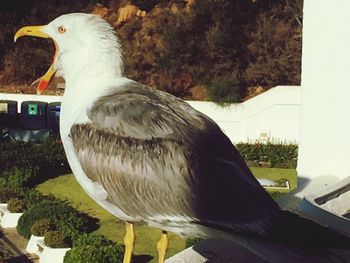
[71,82,278,235]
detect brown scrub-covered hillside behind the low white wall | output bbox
[0,0,302,102]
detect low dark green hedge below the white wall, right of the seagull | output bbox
[235,143,298,168]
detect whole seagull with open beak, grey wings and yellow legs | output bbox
[15,13,350,263]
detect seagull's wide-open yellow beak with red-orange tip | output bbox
[14,26,58,95]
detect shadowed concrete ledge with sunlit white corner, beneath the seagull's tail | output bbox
[165,236,350,263]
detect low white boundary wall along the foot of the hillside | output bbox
[0,86,300,143]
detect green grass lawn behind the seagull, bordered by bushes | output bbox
[37,167,297,262]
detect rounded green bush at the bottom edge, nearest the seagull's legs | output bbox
[64,234,124,263]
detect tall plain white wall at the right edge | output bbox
[298,0,350,184]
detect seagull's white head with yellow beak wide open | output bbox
[15,13,123,93]
